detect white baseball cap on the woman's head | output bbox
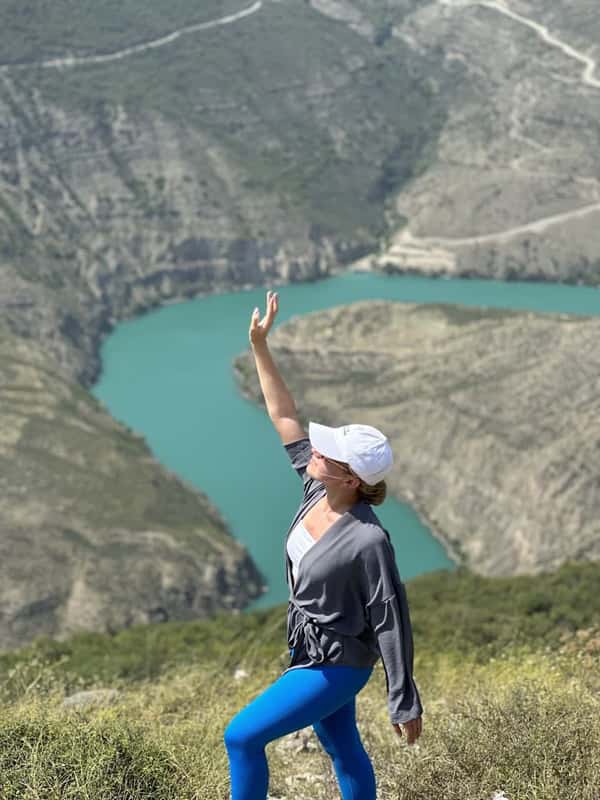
[308,422,394,486]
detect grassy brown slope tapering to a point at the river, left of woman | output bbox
[0,322,262,648]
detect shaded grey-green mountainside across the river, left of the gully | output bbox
[0,0,447,385]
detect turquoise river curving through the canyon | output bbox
[93,273,600,611]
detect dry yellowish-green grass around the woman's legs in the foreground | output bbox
[0,645,600,800]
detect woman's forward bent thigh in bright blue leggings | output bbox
[225,665,373,748]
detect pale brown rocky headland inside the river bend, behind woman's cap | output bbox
[233,302,600,575]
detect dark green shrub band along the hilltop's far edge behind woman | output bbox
[0,562,600,696]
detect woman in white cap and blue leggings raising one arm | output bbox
[224,291,423,800]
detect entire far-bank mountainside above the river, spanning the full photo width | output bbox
[0,0,600,310]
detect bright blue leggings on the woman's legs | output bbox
[224,664,375,800]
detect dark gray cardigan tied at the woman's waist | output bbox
[282,438,423,723]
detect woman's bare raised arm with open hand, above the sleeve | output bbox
[248,291,307,444]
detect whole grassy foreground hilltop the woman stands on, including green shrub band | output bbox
[0,563,600,800]
